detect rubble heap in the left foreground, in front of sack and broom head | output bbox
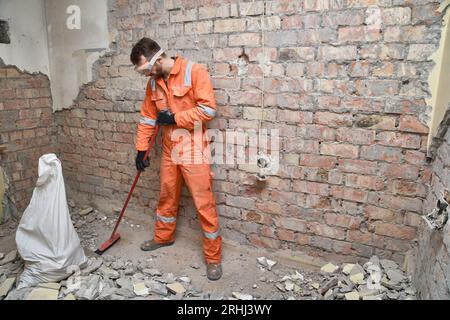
[0,252,203,300]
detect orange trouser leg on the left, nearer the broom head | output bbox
[153,153,183,243]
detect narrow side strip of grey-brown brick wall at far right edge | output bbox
[411,106,450,300]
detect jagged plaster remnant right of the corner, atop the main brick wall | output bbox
[45,0,109,110]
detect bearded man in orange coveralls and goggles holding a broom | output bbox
[130,38,222,280]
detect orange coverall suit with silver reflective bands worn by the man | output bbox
[136,56,222,263]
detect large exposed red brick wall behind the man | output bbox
[56,0,440,262]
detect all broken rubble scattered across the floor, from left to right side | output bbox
[0,200,416,300]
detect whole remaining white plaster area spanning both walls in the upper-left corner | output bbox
[0,0,110,111]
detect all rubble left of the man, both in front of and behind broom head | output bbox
[0,200,203,300]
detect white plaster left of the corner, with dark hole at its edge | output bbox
[0,0,50,76]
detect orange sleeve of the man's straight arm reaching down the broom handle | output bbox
[136,81,156,151]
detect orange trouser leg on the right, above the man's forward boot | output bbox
[180,164,222,263]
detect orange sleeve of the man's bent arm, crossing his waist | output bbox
[175,64,217,130]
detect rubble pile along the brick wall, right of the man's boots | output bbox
[231,256,416,300]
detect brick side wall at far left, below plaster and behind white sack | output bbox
[0,66,56,211]
